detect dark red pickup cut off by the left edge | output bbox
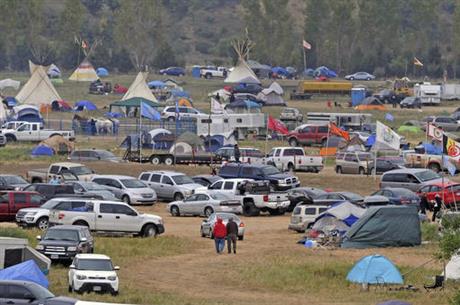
[0,191,45,221]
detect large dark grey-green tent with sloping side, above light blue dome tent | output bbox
[342,206,422,248]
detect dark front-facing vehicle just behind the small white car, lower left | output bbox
[35,225,94,260]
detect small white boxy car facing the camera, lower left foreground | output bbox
[68,254,120,295]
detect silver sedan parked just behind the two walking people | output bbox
[167,193,243,217]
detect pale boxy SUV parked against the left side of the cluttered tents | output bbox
[288,203,330,233]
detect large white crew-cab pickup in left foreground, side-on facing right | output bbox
[49,200,165,237]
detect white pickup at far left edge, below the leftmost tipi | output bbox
[2,122,75,142]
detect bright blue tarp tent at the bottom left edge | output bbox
[0,259,49,288]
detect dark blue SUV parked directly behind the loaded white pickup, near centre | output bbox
[219,163,300,191]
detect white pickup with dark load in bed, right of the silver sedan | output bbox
[195,178,290,216]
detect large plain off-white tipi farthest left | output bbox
[16,66,62,105]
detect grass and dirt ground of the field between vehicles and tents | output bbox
[0,73,460,305]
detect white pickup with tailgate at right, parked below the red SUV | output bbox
[265,147,324,173]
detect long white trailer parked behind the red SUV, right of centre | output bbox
[307,112,372,130]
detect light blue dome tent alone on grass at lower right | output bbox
[347,254,404,284]
